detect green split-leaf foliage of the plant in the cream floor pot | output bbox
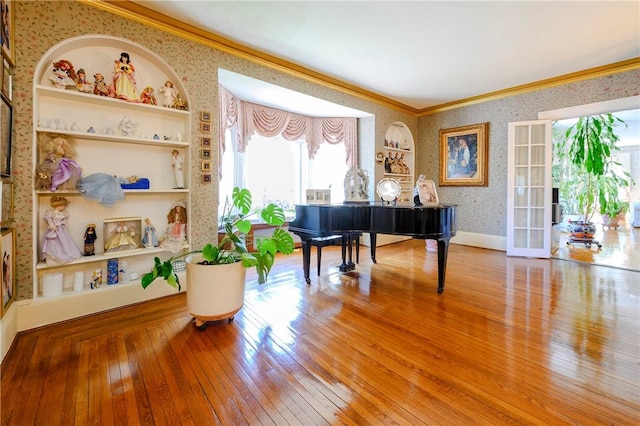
[141,187,294,290]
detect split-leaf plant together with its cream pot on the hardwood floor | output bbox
[141,187,294,328]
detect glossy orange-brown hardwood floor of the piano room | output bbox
[0,241,640,425]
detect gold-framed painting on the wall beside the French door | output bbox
[440,123,489,186]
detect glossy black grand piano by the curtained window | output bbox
[289,202,457,293]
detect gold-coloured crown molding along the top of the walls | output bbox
[86,0,640,117]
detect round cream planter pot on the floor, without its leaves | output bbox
[186,254,246,328]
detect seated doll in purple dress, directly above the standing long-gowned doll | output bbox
[35,137,82,191]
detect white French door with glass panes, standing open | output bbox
[507,120,553,258]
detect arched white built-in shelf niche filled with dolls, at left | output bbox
[33,35,192,308]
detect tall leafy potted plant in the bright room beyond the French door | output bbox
[554,114,631,243]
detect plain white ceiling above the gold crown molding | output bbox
[136,0,640,115]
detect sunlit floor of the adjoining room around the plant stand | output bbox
[551,221,640,271]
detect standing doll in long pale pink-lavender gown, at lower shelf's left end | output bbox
[40,197,82,265]
